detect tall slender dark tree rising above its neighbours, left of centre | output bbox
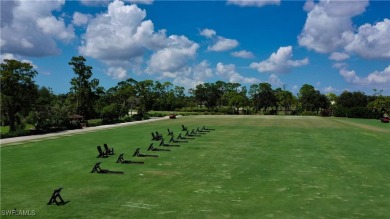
[68,56,99,119]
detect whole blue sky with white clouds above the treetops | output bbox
[1,0,390,95]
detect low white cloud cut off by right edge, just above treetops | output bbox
[340,65,390,87]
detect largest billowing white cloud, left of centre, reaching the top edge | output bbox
[79,1,166,62]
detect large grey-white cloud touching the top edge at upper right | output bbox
[298,0,368,53]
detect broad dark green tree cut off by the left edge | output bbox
[0,59,38,131]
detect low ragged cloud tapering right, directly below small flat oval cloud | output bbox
[216,62,260,84]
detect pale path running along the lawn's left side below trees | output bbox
[0,116,169,147]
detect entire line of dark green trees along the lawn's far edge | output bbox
[1,56,390,135]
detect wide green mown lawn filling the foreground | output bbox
[1,116,390,219]
